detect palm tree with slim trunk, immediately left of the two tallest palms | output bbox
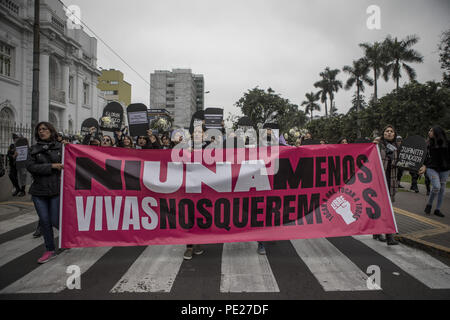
[342,58,373,138]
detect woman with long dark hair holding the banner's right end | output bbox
[373,125,399,246]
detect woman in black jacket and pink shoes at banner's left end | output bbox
[27,122,64,263]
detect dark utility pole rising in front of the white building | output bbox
[31,0,41,134]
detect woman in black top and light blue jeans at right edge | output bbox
[419,126,450,218]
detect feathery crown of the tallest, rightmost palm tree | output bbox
[383,35,423,90]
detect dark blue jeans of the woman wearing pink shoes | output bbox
[31,196,59,251]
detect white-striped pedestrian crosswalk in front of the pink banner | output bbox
[0,214,450,299]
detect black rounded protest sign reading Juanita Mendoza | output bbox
[397,136,427,171]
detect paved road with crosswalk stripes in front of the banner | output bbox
[0,210,450,300]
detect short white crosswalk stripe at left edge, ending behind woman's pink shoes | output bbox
[0,233,43,267]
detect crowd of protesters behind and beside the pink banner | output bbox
[2,117,450,263]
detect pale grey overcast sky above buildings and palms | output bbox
[63,0,450,122]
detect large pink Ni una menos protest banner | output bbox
[60,144,397,248]
